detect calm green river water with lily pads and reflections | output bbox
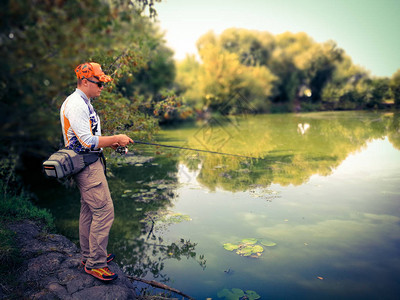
[39,112,400,299]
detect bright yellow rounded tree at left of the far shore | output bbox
[192,30,276,114]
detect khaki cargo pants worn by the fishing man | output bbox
[74,159,114,269]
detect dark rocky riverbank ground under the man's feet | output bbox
[0,221,138,299]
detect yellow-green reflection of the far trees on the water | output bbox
[163,112,400,191]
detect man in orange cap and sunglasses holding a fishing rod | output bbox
[60,62,133,280]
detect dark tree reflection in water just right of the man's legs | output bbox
[110,157,206,282]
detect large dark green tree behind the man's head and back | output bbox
[0,0,173,177]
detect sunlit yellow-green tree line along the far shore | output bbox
[176,28,400,114]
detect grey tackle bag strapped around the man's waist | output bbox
[43,149,101,178]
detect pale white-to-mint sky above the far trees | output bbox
[155,0,400,77]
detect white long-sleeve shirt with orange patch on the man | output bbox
[60,89,101,152]
